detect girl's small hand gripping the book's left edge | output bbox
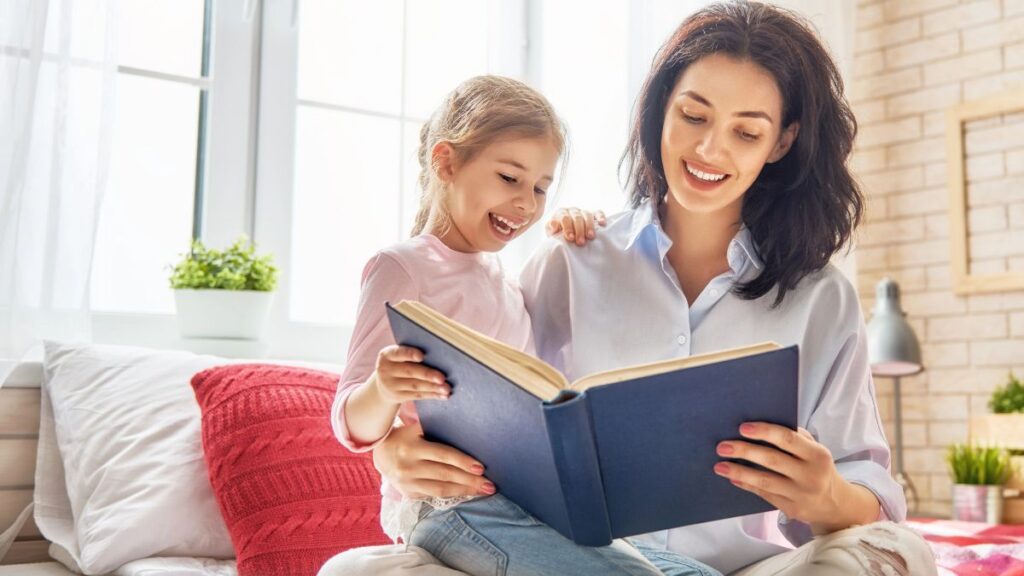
[374,345,452,404]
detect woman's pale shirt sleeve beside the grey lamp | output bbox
[779,272,906,546]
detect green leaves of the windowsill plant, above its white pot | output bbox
[170,236,278,292]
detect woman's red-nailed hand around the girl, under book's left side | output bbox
[374,424,496,498]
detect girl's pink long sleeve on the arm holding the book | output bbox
[331,253,419,452]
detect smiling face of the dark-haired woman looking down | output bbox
[662,54,800,219]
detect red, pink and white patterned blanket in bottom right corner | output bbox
[907,519,1024,576]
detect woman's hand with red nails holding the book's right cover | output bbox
[715,422,879,533]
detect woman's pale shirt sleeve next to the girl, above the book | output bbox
[519,239,572,373]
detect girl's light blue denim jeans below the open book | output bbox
[409,494,721,576]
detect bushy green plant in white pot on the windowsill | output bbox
[170,236,278,340]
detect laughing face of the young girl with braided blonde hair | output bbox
[434,138,559,252]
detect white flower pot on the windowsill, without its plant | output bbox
[174,290,273,340]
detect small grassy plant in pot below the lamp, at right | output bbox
[946,444,1013,524]
